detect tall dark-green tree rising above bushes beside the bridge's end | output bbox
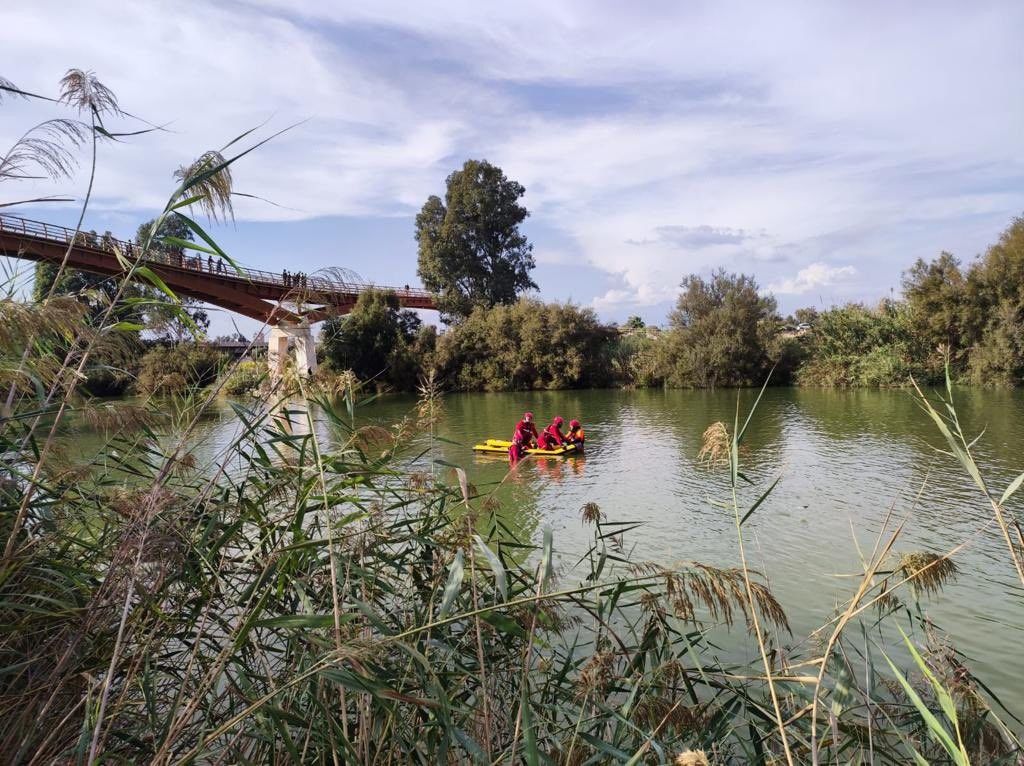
[416,160,537,321]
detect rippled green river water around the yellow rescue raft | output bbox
[77,388,1024,715]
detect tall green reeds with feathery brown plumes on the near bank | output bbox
[0,72,1024,766]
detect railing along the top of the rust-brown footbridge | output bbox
[0,214,431,299]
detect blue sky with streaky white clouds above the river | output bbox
[0,0,1024,334]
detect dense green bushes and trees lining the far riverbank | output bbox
[323,219,1024,391]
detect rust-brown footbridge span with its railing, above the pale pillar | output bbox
[0,215,434,323]
